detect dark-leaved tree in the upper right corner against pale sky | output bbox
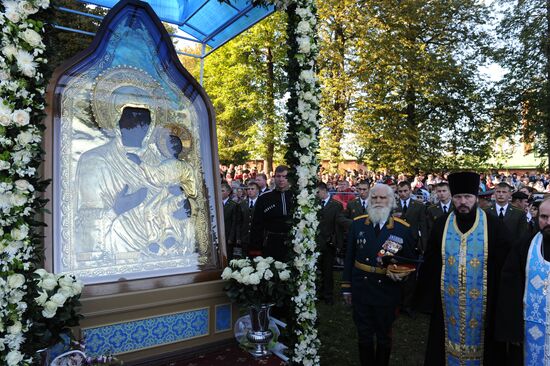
[494,0,550,169]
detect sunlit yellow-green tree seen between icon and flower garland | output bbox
[204,12,286,170]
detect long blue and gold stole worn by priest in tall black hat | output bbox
[441,209,488,366]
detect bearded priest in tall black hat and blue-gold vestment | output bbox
[415,172,511,366]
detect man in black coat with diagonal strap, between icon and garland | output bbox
[250,165,294,262]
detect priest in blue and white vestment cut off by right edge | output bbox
[497,198,550,366]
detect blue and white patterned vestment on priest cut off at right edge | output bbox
[523,233,550,366]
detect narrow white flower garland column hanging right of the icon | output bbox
[272,0,320,366]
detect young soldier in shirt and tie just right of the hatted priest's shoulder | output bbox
[485,182,529,244]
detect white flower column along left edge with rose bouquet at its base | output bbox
[0,0,82,366]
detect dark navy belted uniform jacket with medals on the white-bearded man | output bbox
[342,215,414,306]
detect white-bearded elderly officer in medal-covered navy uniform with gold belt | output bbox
[342,184,414,366]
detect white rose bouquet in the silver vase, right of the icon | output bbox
[222,257,290,306]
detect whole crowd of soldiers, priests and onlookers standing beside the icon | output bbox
[221,166,550,366]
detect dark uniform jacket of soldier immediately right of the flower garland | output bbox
[317,198,345,251]
